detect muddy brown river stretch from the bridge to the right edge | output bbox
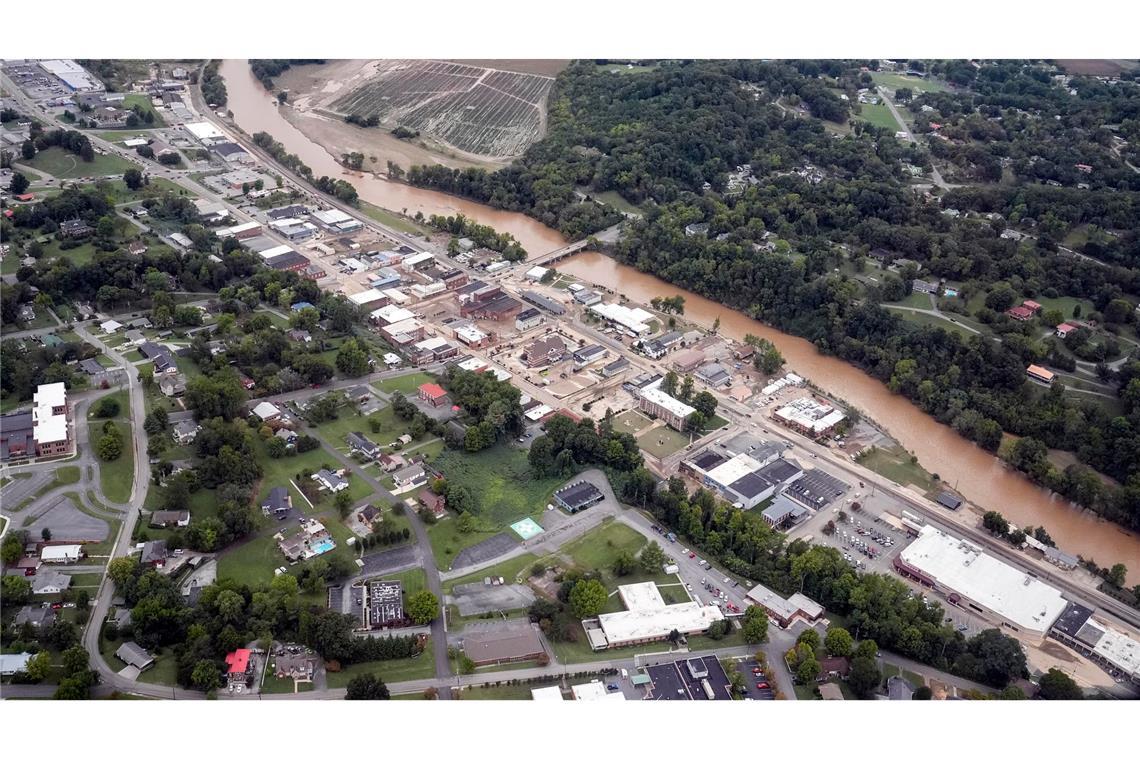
[557,252,1140,572]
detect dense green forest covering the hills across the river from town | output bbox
[407,62,1140,528]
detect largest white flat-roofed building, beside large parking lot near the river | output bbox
[894,525,1066,636]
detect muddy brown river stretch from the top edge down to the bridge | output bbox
[219,58,567,255]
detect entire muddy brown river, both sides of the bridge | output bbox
[220,59,1140,572]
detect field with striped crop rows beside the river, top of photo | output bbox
[328,60,554,158]
